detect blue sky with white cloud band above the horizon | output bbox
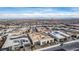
[0,7,79,19]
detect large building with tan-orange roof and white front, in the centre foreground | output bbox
[29,32,54,45]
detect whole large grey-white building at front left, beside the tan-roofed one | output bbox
[2,34,31,50]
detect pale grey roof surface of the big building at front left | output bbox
[2,35,30,48]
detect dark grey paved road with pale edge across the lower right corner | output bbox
[37,40,79,51]
